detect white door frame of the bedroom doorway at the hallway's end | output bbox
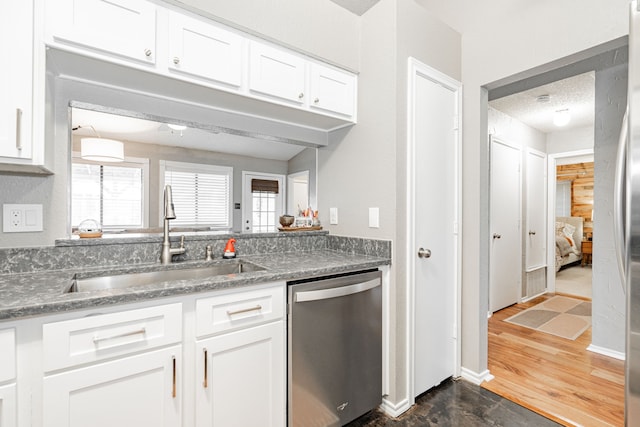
[547,148,594,292]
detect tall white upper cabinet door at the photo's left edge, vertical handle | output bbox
[0,0,33,159]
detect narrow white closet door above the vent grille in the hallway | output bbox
[525,148,547,272]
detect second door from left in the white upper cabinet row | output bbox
[169,12,243,87]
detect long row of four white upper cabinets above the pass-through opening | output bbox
[43,0,357,127]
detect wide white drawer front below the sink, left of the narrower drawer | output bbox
[42,303,182,372]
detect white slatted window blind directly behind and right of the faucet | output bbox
[161,161,233,229]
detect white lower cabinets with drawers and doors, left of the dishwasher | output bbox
[6,282,287,427]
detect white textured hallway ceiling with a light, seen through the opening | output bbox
[489,72,595,133]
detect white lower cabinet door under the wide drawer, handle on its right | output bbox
[43,346,182,427]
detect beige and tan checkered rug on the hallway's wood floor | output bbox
[504,296,591,340]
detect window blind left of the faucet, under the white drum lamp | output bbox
[71,158,146,230]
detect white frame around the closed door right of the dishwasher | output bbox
[405,57,462,409]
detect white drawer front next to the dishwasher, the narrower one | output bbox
[196,284,284,337]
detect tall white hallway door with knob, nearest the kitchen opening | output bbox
[489,138,522,313]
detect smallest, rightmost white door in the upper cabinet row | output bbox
[309,64,356,117]
